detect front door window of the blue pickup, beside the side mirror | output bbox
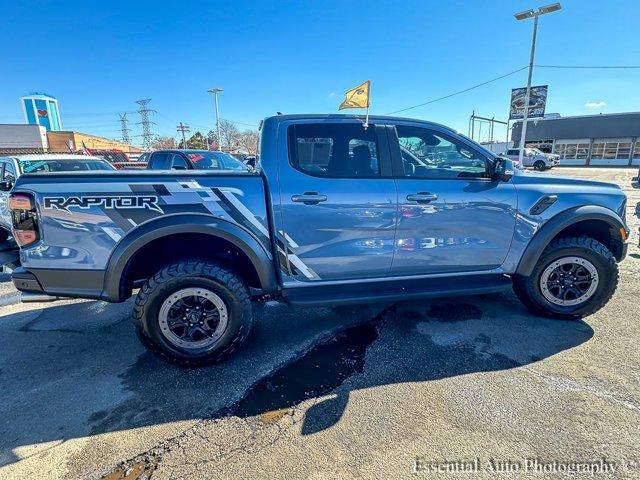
[396,125,488,179]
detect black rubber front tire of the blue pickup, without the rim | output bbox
[513,236,618,320]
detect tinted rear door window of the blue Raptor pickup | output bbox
[289,123,380,178]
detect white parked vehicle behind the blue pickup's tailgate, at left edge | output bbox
[0,154,114,242]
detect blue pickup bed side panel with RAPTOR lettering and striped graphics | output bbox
[13,170,270,284]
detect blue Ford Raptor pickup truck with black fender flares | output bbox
[9,115,629,366]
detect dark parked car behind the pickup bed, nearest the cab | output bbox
[147,149,247,171]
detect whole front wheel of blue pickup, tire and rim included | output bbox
[513,237,618,319]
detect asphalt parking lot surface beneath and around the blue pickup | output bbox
[0,168,640,480]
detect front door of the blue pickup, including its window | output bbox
[390,125,517,275]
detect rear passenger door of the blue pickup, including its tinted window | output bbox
[276,119,397,283]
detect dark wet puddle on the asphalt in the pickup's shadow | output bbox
[232,322,378,423]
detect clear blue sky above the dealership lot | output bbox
[0,0,640,142]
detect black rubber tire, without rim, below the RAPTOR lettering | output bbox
[133,261,253,367]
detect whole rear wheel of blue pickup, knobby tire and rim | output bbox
[133,261,253,367]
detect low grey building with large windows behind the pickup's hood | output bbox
[511,112,640,166]
